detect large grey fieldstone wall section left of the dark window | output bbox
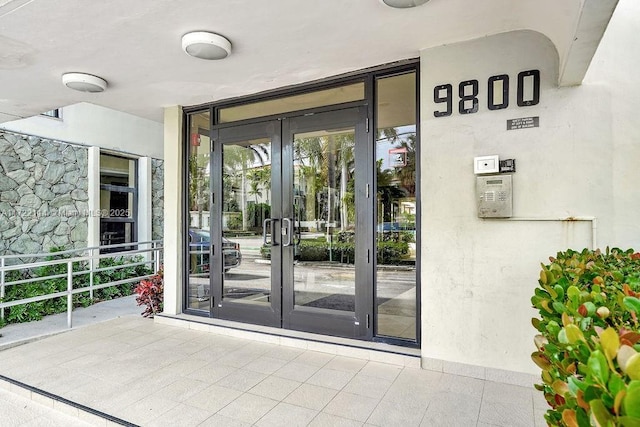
[0,131,90,254]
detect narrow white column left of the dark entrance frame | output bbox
[164,106,184,314]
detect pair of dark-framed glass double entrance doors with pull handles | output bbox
[211,108,373,339]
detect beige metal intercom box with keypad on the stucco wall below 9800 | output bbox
[476,175,513,218]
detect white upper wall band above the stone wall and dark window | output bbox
[0,102,164,159]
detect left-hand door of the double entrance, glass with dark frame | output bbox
[212,122,281,326]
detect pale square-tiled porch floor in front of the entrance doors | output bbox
[0,316,545,427]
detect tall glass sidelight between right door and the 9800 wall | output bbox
[376,72,417,340]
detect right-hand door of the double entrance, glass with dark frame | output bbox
[282,109,371,337]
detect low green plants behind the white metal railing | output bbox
[0,247,152,327]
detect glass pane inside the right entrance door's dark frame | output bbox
[291,128,356,313]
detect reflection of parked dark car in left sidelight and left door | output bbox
[189,228,242,274]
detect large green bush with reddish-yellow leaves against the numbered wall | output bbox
[531,249,640,427]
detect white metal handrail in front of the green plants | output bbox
[0,240,164,328]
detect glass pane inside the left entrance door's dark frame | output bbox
[222,138,272,306]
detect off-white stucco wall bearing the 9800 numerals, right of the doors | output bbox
[421,0,640,374]
